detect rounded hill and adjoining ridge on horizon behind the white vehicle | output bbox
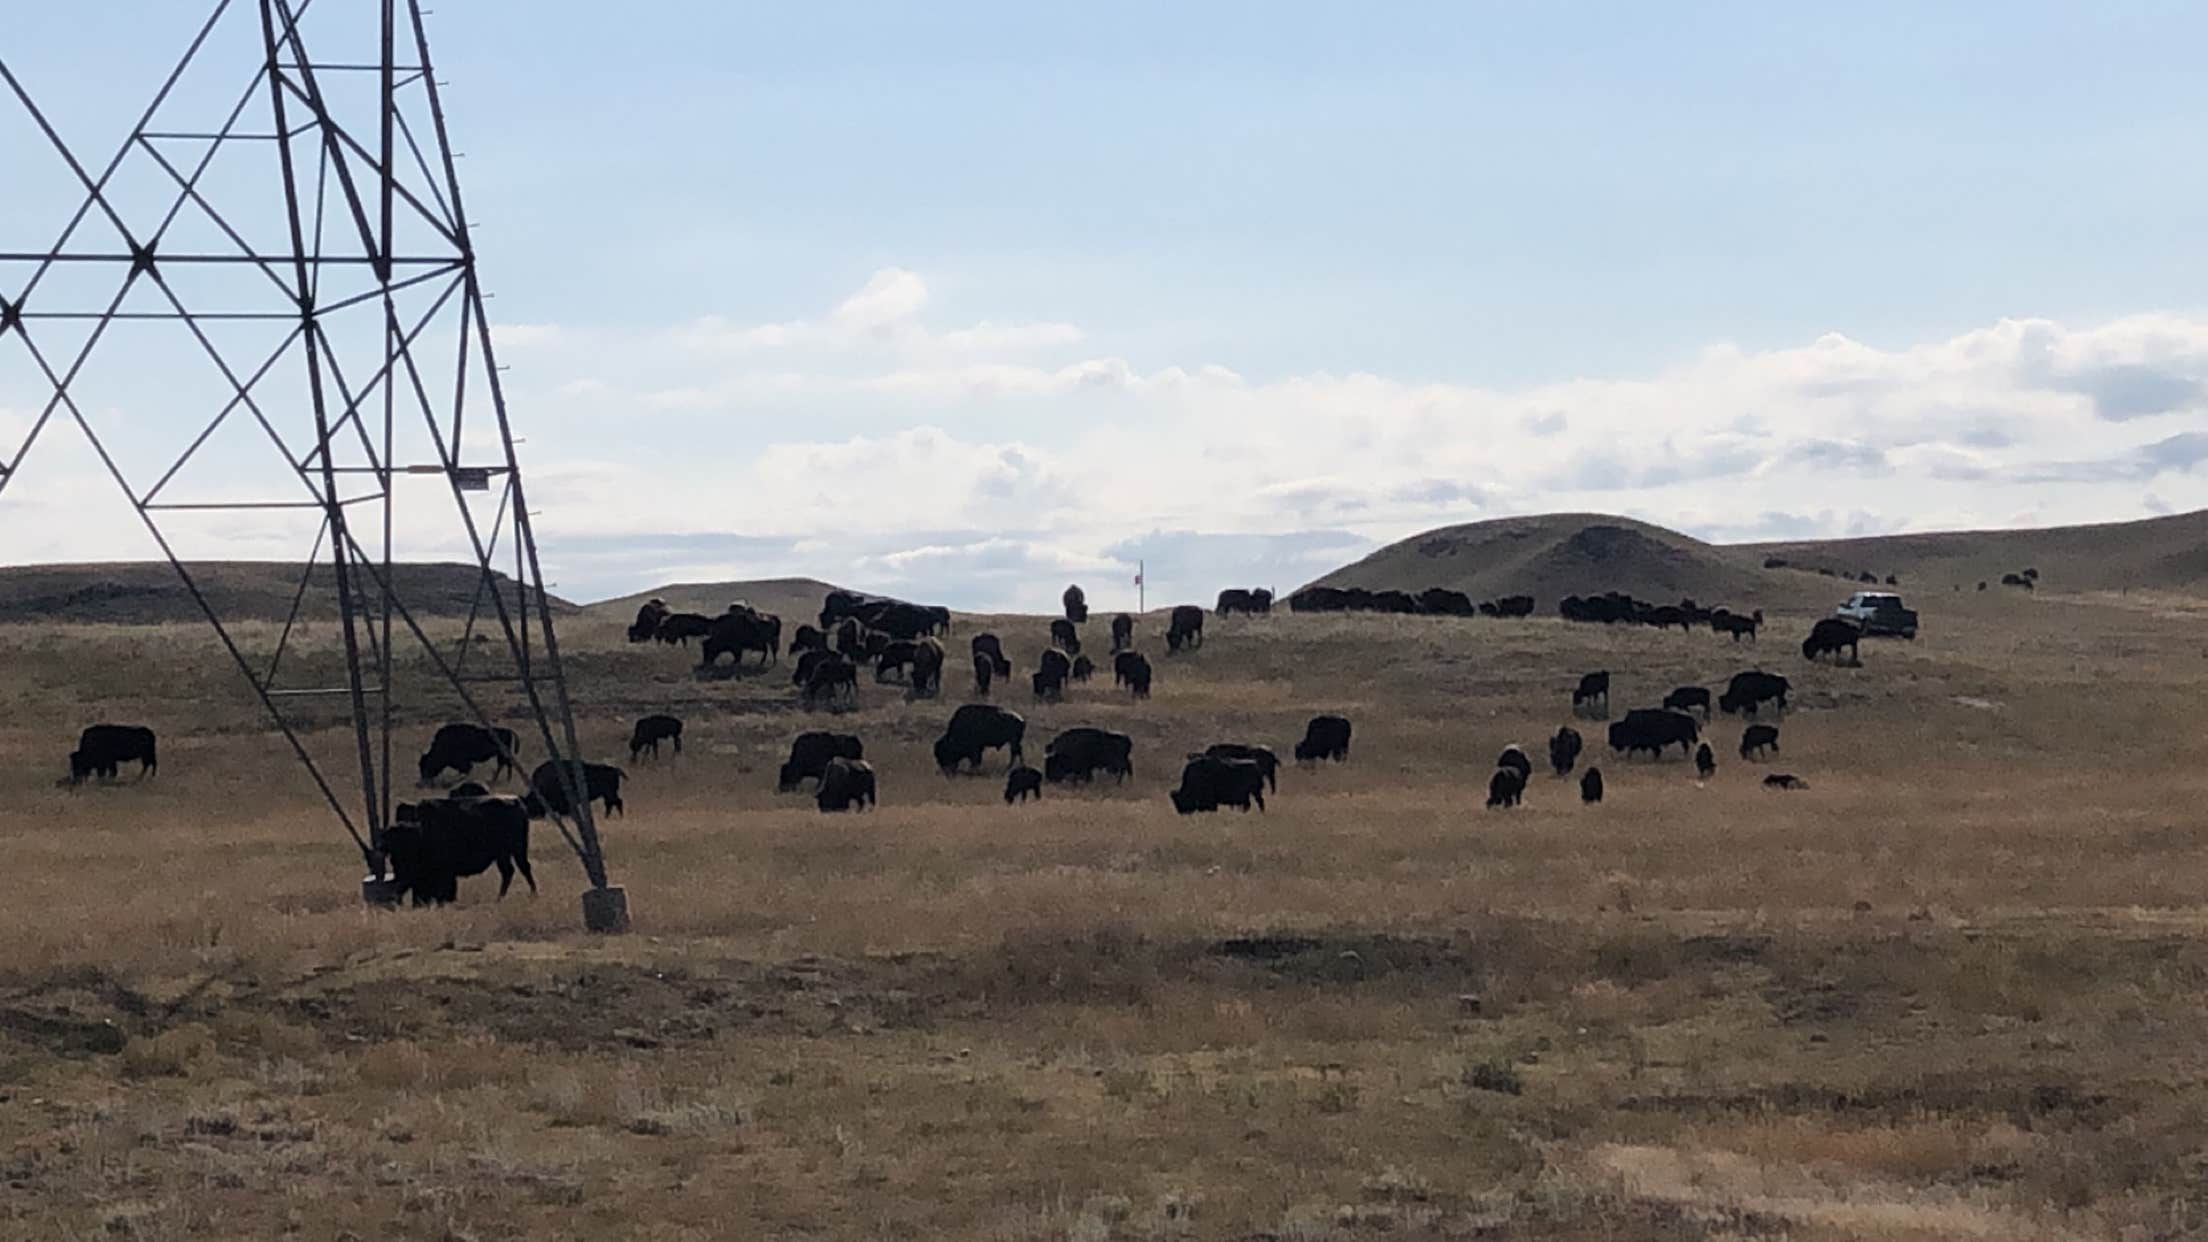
[1314,513,2208,610]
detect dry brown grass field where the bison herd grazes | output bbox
[0,574,2208,1242]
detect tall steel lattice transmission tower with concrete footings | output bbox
[0,0,625,926]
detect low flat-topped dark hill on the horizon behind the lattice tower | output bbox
[0,561,574,625]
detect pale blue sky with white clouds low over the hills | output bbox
[0,0,2208,608]
